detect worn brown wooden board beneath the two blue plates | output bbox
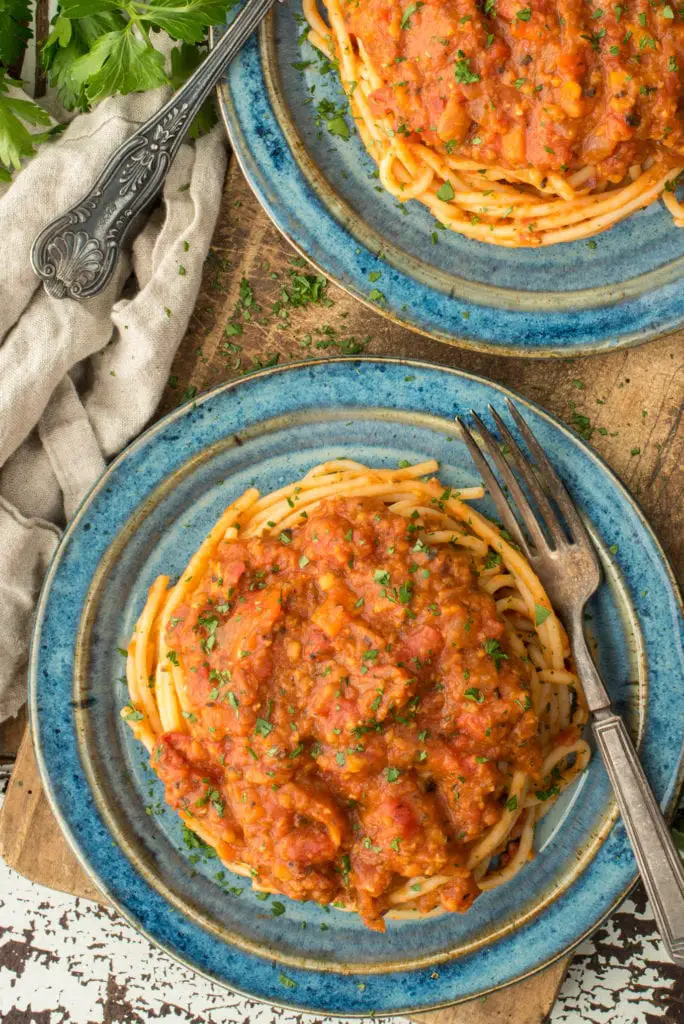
[0,162,684,1024]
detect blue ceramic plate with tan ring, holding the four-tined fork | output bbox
[31,359,684,1016]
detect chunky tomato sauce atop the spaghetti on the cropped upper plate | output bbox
[344,0,684,186]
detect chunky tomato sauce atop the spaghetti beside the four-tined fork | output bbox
[152,498,542,929]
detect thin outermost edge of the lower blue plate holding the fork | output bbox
[28,355,684,1018]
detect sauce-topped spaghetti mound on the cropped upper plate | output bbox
[303,0,684,247]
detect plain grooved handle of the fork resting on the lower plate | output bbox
[594,710,684,966]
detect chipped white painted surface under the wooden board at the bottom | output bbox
[0,790,684,1024]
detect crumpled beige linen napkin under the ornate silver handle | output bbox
[0,89,226,721]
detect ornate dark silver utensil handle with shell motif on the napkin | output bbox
[31,0,274,299]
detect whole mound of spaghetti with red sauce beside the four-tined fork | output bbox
[122,460,589,930]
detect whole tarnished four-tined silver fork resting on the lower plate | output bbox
[457,400,684,965]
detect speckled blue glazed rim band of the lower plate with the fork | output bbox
[29,357,684,1017]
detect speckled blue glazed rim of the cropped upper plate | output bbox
[211,18,684,358]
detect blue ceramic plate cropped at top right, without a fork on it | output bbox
[219,9,684,356]
